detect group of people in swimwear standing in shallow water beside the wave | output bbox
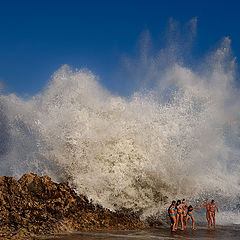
[168,199,218,232]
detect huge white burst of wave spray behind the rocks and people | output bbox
[0,19,240,224]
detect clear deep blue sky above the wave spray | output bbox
[0,0,240,95]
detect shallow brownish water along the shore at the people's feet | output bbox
[39,225,240,240]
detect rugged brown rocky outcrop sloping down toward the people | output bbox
[0,174,148,239]
